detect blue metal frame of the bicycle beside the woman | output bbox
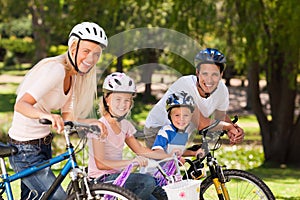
[0,123,84,200]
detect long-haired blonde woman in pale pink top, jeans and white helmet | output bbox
[8,22,107,200]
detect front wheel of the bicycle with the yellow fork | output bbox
[200,169,275,200]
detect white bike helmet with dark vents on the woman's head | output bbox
[68,22,108,48]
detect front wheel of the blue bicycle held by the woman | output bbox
[67,183,139,200]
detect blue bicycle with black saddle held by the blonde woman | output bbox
[0,119,138,200]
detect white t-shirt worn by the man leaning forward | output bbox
[145,75,229,128]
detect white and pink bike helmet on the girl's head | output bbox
[102,72,136,93]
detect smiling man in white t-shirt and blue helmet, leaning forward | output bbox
[144,48,244,147]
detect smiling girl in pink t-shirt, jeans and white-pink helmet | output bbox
[88,72,171,200]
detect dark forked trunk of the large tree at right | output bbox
[249,58,300,166]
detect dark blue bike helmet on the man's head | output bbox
[194,48,226,73]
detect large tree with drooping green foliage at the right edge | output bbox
[224,0,300,166]
